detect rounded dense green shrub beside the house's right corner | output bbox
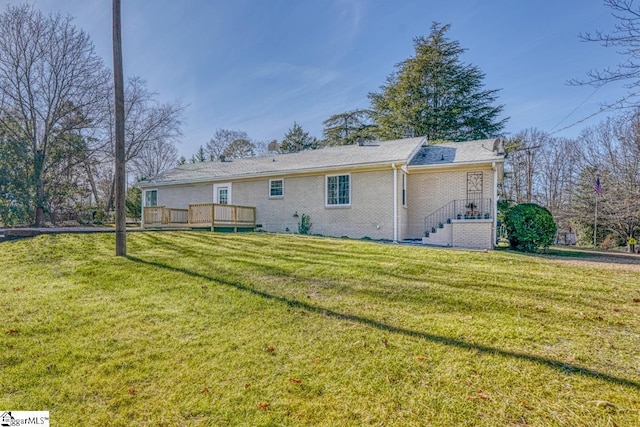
[505,203,557,252]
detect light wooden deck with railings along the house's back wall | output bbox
[142,203,256,232]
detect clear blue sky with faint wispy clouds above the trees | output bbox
[18,0,626,157]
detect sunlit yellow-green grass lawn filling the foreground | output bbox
[0,232,640,427]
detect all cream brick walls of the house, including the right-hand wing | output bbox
[150,166,500,248]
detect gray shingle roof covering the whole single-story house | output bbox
[140,137,498,187]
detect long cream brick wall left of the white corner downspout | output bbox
[158,167,402,239]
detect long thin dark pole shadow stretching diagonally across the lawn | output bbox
[127,255,640,390]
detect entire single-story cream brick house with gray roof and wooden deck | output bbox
[140,138,504,248]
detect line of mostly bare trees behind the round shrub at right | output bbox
[501,110,640,247]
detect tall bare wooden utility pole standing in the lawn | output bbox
[113,0,127,256]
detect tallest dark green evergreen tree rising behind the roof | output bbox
[369,23,507,141]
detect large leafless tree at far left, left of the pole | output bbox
[0,5,109,226]
